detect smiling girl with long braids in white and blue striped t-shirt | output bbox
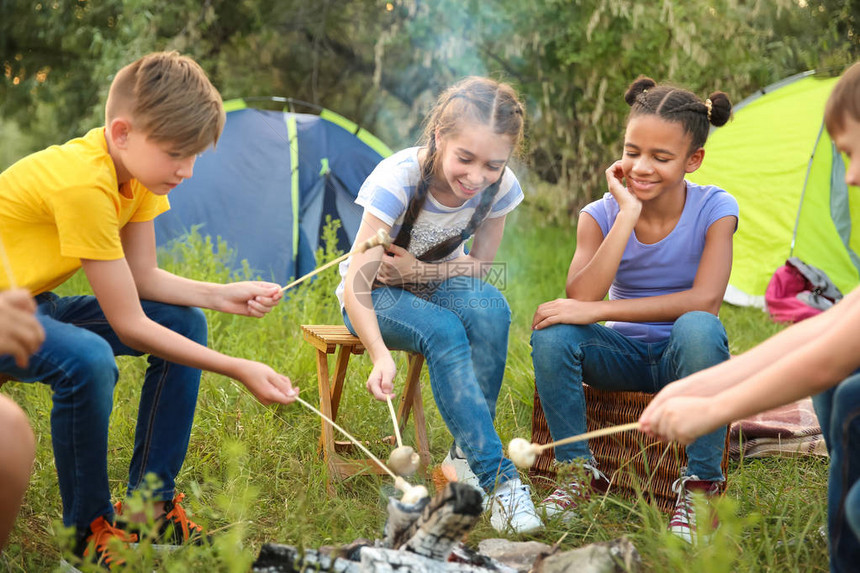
[338,77,541,532]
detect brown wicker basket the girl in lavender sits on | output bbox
[529,384,729,512]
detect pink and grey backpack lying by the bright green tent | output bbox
[764,257,842,322]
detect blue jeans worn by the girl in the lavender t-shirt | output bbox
[532,311,729,481]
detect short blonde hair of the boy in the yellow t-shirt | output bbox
[105,52,225,156]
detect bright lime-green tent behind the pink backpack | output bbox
[689,72,860,307]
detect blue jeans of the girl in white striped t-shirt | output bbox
[343,277,519,491]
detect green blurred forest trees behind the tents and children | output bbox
[5,0,860,218]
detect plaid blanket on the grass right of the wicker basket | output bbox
[729,398,827,460]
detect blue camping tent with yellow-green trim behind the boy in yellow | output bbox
[155,98,391,284]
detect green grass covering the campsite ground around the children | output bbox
[0,208,828,572]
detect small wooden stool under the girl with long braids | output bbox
[302,324,430,490]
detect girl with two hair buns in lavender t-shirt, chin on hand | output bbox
[532,78,738,542]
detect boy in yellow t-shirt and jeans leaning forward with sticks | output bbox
[0,52,297,564]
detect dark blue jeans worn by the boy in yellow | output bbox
[0,293,207,534]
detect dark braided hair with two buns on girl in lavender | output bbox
[624,76,732,152]
